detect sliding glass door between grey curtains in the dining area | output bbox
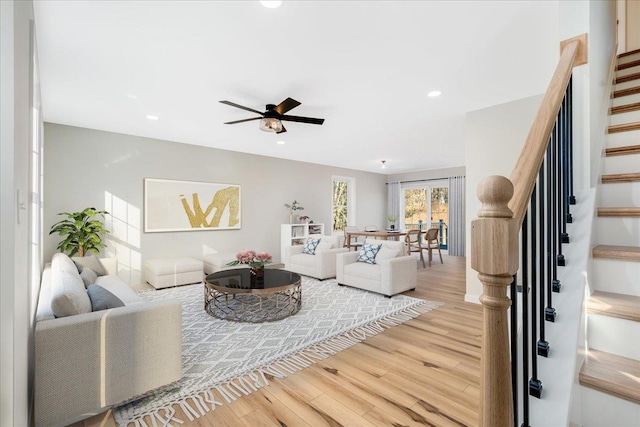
[402,181,449,249]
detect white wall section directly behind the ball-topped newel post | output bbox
[465,95,542,303]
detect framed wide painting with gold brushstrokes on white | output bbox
[144,178,241,233]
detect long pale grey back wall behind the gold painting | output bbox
[44,123,387,283]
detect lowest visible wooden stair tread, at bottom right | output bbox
[580,350,640,404]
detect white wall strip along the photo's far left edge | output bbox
[0,1,35,426]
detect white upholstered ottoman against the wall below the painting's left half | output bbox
[144,258,203,289]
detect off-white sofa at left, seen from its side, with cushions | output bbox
[34,254,182,426]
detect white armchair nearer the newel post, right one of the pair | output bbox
[336,239,418,297]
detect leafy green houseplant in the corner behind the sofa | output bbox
[49,208,109,256]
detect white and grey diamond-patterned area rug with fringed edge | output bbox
[113,276,440,427]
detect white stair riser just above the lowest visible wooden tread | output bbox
[587,313,640,360]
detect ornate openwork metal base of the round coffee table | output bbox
[204,281,302,323]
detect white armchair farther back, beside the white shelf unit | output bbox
[284,236,347,280]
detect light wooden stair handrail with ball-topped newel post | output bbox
[471,34,587,427]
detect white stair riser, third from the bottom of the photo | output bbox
[589,258,640,297]
